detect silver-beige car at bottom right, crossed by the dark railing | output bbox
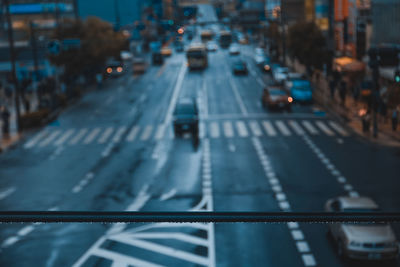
[325,196,399,261]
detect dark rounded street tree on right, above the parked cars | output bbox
[287,22,332,75]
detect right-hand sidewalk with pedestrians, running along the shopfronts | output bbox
[312,70,400,146]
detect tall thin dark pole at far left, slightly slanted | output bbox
[4,0,21,132]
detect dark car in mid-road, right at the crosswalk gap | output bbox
[173,98,199,138]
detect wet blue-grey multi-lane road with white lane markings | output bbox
[0,6,400,267]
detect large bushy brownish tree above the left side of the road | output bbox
[50,17,127,83]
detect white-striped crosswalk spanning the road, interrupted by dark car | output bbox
[24,119,350,149]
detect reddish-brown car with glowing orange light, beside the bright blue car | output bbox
[261,86,293,111]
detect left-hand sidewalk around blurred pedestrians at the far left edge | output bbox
[0,93,38,153]
